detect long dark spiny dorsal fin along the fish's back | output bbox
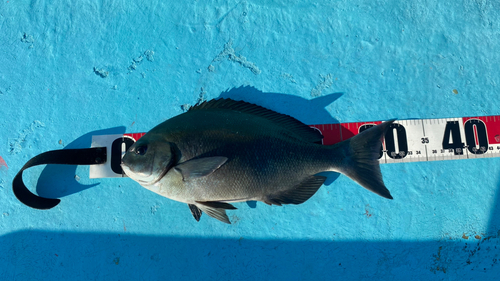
[188,98,323,143]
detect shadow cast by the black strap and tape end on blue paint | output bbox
[36,126,126,198]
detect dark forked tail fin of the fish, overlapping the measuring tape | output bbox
[332,119,395,199]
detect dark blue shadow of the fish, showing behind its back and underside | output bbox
[219,86,342,208]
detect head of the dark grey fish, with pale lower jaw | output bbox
[121,136,174,185]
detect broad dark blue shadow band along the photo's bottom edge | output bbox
[0,231,500,280]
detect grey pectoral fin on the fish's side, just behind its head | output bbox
[174,156,228,181]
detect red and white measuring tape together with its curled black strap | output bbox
[12,113,500,210]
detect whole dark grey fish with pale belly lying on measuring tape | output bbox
[121,98,395,224]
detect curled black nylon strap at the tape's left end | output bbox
[12,147,107,210]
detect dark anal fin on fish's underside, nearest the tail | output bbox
[264,176,326,206]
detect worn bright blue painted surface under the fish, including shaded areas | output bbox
[0,0,500,280]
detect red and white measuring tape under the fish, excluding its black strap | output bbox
[89,115,500,178]
